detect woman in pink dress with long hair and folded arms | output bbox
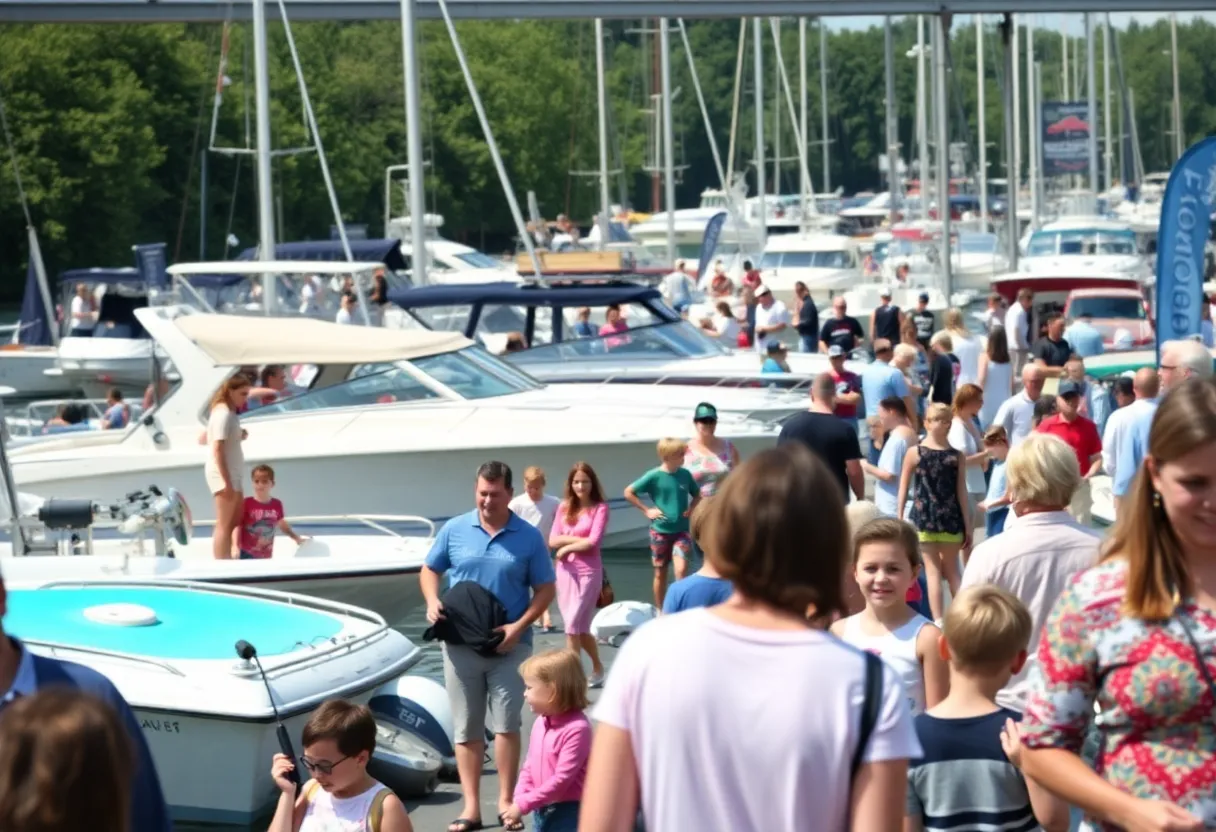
[548,462,608,687]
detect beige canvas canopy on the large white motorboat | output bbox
[174,314,473,366]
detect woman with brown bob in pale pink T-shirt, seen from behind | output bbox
[579,443,921,832]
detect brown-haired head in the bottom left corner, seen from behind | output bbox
[0,688,135,832]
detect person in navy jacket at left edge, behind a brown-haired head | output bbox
[0,569,173,832]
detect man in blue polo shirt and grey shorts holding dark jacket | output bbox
[420,462,556,832]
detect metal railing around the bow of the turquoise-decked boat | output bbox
[24,580,403,676]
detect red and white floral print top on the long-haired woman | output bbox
[1021,560,1216,832]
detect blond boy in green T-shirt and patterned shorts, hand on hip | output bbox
[625,439,700,609]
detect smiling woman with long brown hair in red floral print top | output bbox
[1007,378,1216,832]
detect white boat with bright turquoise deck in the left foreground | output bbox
[5,581,423,826]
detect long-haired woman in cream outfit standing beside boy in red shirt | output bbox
[203,372,249,560]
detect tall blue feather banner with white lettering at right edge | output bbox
[1156,137,1216,364]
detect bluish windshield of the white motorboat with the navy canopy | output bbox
[510,321,730,366]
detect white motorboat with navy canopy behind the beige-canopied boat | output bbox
[384,282,831,394]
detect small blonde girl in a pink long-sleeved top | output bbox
[500,650,591,832]
